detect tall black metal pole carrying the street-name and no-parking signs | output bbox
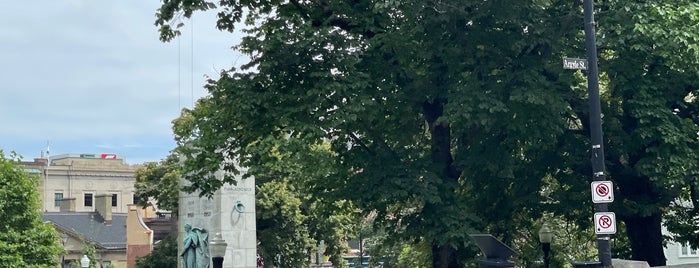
[583,0,612,268]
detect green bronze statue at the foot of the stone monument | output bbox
[180,223,209,268]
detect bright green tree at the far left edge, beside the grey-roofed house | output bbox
[0,150,63,267]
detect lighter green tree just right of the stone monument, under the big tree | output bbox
[241,138,359,267]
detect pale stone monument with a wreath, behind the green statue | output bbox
[177,172,257,268]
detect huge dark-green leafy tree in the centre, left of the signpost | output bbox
[157,1,575,267]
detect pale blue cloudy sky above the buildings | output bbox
[0,0,245,164]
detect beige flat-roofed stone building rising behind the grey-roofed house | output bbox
[22,154,136,213]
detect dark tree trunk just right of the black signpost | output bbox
[624,212,665,266]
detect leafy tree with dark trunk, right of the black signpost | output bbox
[600,1,699,266]
